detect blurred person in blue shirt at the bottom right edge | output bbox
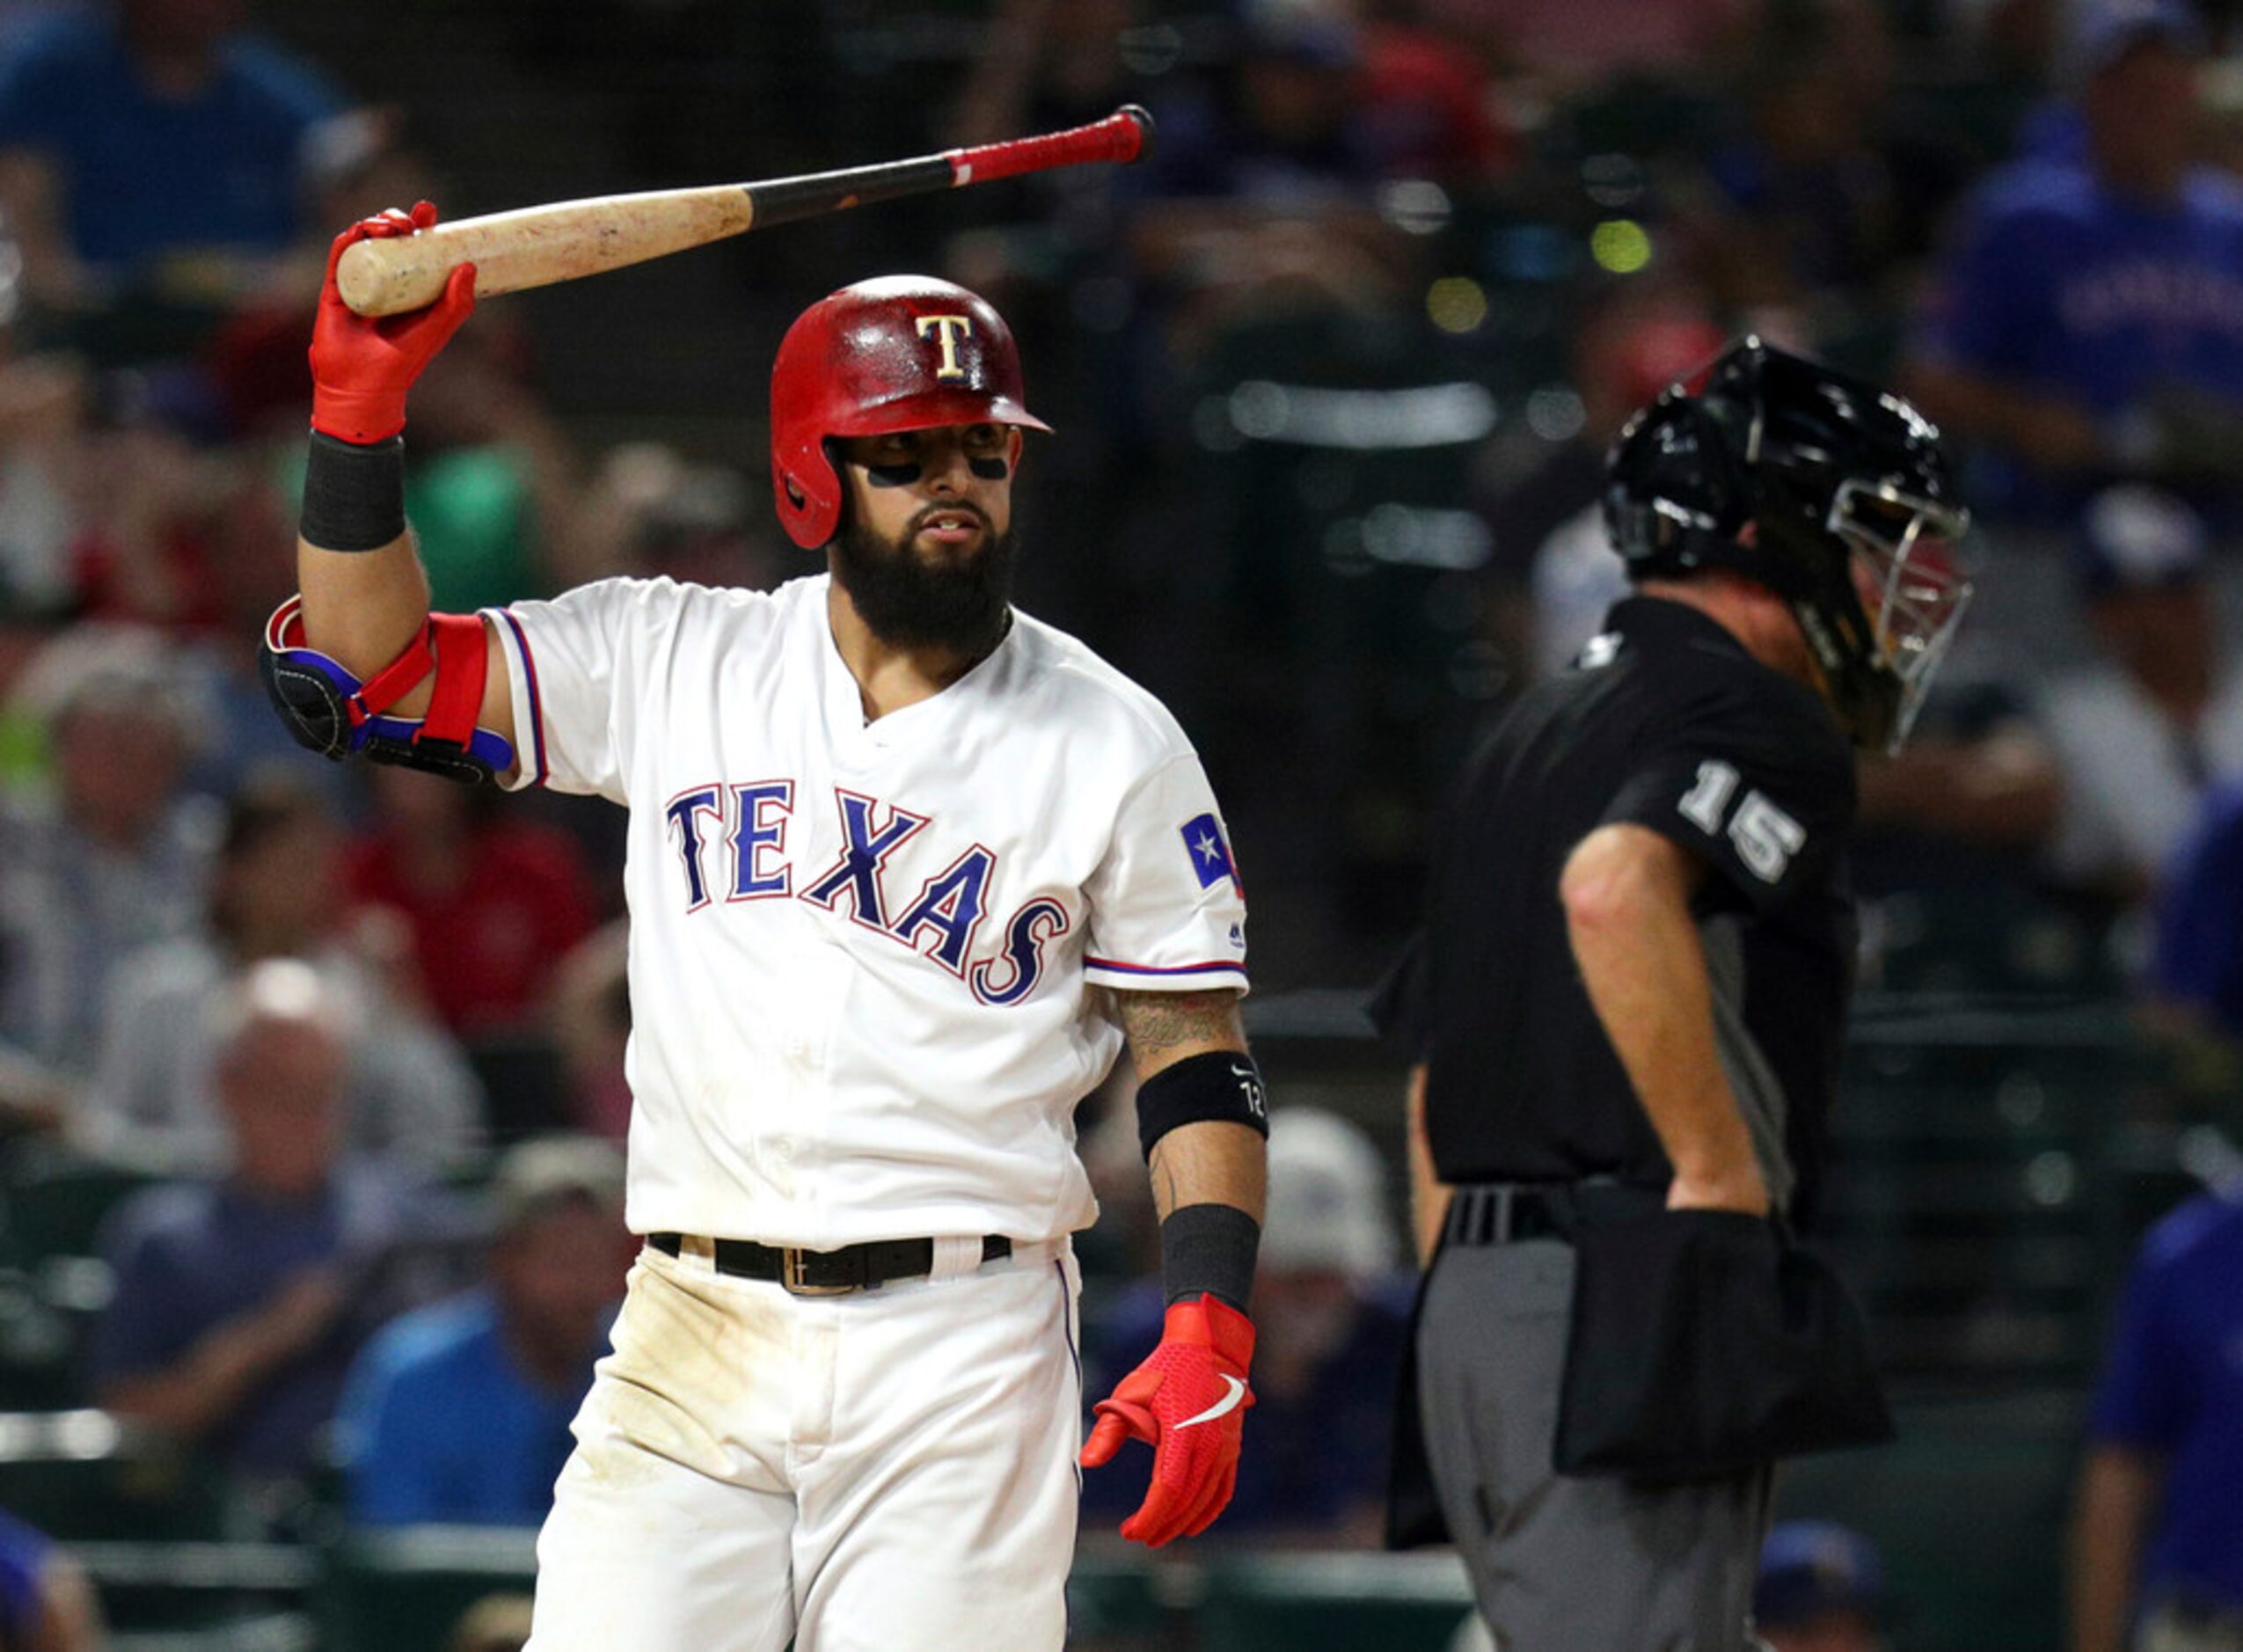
[2072,1192,2243,1652]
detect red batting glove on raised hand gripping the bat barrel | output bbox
[311,202,476,442]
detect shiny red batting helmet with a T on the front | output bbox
[771,276,1052,550]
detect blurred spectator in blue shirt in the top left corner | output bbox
[0,0,343,332]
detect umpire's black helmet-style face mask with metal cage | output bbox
[1604,337,1971,749]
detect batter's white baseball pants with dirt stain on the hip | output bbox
[530,1241,1081,1652]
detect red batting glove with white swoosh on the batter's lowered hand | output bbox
[1081,1295,1253,1549]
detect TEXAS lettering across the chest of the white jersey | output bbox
[664,778,1068,1005]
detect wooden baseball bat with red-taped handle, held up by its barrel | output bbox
[334,103,1153,317]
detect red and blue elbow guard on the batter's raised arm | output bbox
[258,597,514,786]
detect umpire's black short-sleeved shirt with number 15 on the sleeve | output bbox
[1377,597,1855,1221]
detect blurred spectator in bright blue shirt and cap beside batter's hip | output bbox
[341,1136,631,1526]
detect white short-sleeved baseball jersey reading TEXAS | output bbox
[486,574,1247,1250]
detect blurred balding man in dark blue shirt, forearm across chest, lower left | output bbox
[92,959,462,1490]
